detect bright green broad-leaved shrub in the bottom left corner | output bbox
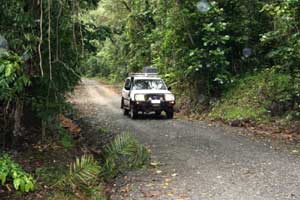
[0,154,35,192]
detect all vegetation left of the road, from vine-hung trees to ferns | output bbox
[0,0,150,200]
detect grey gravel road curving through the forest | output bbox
[72,79,300,200]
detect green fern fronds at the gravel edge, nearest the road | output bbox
[103,133,150,178]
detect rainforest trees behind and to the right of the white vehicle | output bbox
[84,0,300,122]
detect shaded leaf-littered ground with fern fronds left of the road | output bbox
[0,114,150,200]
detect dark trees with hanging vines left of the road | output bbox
[0,0,101,145]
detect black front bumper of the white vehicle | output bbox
[131,101,175,113]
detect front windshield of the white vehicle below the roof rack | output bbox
[133,80,167,90]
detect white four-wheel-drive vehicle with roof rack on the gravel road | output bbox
[121,70,175,119]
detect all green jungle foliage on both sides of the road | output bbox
[0,0,300,199]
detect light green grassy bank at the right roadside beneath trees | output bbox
[208,68,290,122]
